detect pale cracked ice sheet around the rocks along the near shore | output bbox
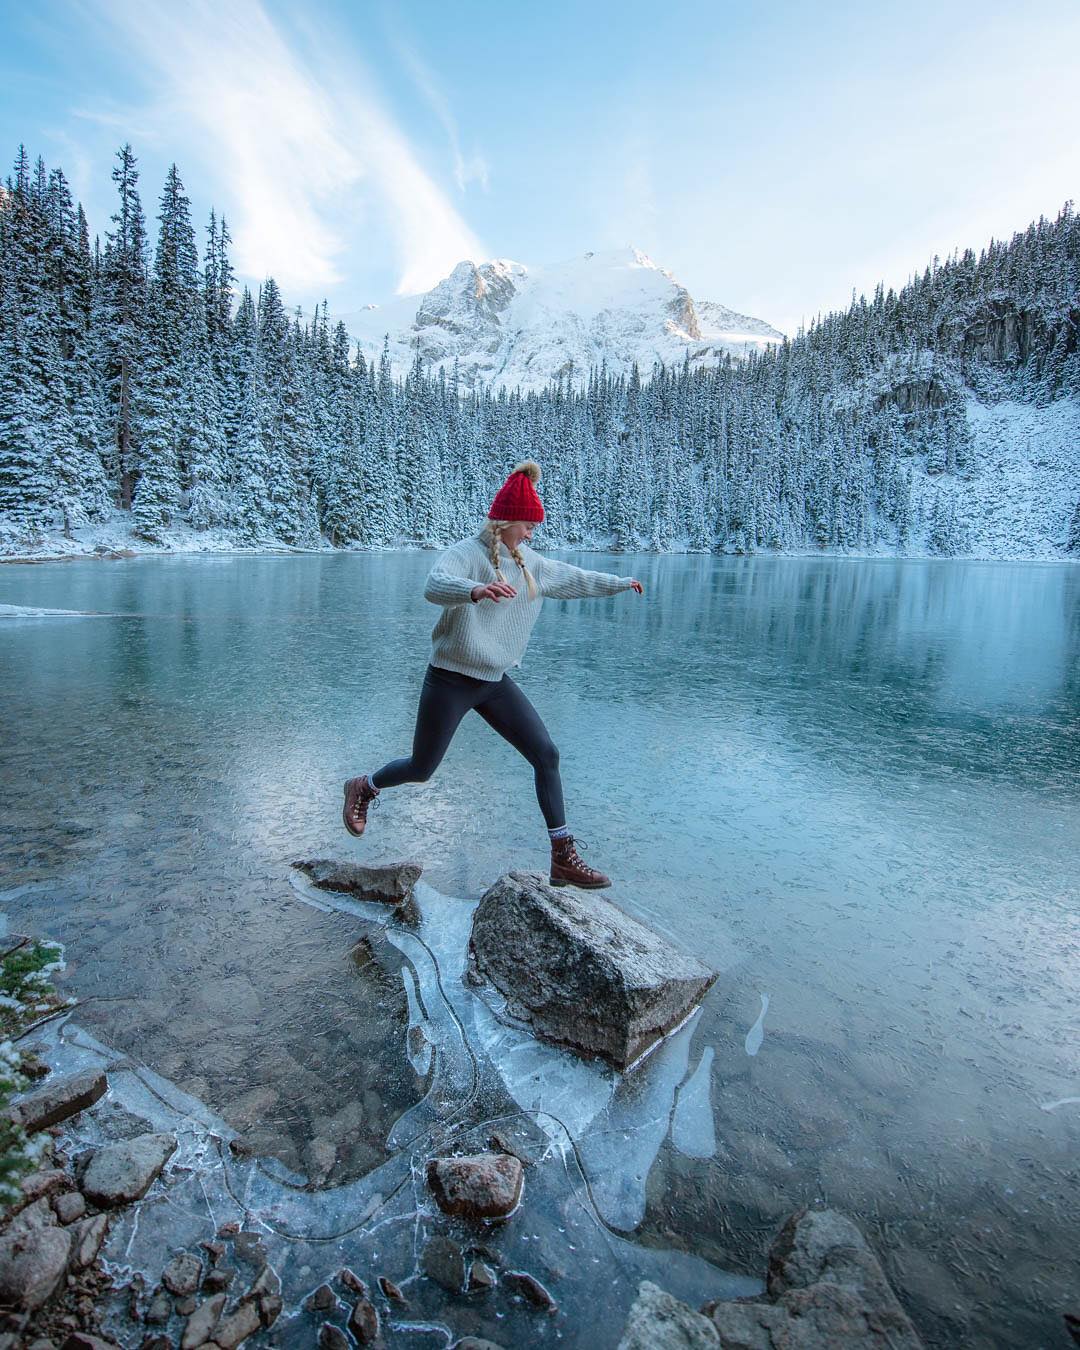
[12,878,761,1345]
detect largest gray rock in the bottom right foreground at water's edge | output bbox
[702,1210,922,1350]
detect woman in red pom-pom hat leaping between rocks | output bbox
[343,459,643,890]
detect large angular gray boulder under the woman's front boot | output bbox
[468,872,717,1069]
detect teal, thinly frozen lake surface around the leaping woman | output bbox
[0,540,1080,1347]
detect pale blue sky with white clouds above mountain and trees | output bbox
[0,0,1080,333]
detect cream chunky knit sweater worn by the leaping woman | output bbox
[424,532,632,680]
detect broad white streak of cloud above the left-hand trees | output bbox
[84,0,482,293]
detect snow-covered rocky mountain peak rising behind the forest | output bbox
[339,247,783,390]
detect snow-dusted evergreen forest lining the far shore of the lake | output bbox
[0,146,1080,556]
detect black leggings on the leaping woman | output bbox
[371,666,566,830]
